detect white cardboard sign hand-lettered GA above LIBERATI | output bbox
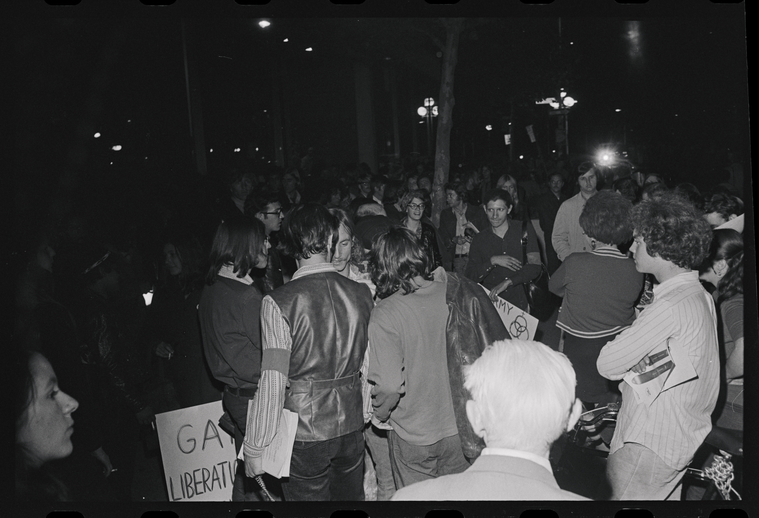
[155,401,237,502]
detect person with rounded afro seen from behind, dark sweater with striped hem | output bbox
[548,191,643,408]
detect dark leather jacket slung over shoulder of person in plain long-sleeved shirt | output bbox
[445,272,511,462]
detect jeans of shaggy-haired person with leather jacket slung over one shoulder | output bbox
[387,431,469,489]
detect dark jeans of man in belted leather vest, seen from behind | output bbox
[282,429,365,502]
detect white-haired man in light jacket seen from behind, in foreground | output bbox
[392,340,586,500]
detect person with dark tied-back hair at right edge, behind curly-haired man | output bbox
[700,229,743,430]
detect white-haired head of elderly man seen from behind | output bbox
[464,340,582,456]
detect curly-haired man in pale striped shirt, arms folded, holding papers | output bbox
[597,192,720,500]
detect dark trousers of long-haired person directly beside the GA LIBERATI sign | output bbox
[222,392,282,502]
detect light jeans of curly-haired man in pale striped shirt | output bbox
[606,442,684,500]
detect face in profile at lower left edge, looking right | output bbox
[16,354,79,466]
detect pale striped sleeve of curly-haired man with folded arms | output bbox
[596,304,674,380]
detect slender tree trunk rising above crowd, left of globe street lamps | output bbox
[432,18,464,230]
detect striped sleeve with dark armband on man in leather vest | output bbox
[243,296,292,457]
